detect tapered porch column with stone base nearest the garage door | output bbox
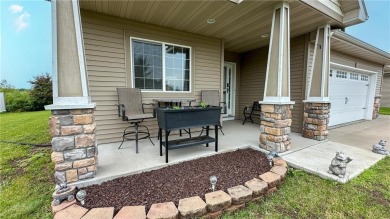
[303,24,330,141]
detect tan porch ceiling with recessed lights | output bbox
[80,0,340,53]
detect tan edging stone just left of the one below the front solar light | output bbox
[178,196,207,219]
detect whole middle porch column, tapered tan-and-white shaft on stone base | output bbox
[259,2,294,152]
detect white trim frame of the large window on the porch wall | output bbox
[129,36,193,94]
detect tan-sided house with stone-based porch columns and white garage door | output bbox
[46,0,390,185]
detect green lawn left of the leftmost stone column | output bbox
[0,111,54,219]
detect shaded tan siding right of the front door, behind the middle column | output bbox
[239,36,305,132]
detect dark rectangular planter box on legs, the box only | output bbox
[157,107,222,131]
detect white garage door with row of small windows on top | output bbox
[329,69,369,126]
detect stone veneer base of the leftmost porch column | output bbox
[49,109,97,183]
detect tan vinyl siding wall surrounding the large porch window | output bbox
[82,11,221,144]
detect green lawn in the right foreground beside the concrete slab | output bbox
[223,157,390,219]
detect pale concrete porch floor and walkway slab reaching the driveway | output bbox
[77,116,390,187]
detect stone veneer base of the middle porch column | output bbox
[260,104,293,153]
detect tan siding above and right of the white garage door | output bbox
[330,50,383,95]
